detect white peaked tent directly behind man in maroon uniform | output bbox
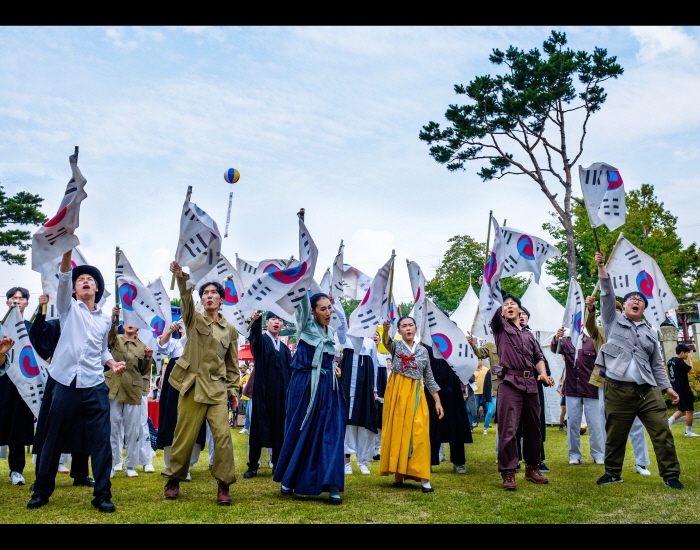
[520,280,564,424]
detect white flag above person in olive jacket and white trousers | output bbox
[115,249,167,337]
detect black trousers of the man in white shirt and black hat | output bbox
[34,379,112,503]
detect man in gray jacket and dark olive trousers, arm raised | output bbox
[595,252,683,489]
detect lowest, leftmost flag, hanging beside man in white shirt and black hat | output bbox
[5,307,48,417]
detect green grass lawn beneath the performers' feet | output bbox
[0,424,700,523]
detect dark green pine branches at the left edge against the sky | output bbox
[0,185,48,265]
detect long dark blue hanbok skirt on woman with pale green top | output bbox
[274,340,347,495]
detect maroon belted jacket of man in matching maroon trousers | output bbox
[491,307,544,393]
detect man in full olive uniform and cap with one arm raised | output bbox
[162,262,240,506]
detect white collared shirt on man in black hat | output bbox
[49,271,112,388]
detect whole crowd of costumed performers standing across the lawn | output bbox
[0,252,694,512]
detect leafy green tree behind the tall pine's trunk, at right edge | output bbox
[543,183,700,304]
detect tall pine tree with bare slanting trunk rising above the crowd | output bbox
[419,31,624,276]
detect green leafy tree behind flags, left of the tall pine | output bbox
[425,235,528,313]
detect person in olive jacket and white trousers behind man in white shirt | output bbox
[105,307,153,477]
